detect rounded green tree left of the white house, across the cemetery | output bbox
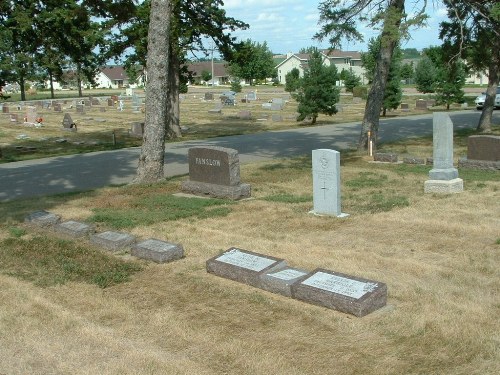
[229,39,276,85]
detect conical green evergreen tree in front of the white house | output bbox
[295,51,340,124]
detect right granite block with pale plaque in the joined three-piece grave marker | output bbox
[291,268,387,317]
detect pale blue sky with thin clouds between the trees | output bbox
[220,0,446,54]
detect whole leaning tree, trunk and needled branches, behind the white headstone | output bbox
[315,0,427,149]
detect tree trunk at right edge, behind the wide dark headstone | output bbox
[476,38,500,133]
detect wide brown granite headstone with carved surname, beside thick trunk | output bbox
[181,146,251,200]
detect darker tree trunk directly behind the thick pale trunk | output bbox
[167,44,182,138]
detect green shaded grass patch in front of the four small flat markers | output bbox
[0,236,141,288]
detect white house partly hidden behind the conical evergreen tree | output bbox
[276,50,365,84]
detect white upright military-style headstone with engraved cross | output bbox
[311,149,349,217]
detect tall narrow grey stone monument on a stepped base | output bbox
[424,112,464,194]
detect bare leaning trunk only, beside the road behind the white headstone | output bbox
[358,0,405,150]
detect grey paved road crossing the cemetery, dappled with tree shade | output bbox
[0,111,500,201]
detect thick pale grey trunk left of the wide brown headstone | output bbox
[134,0,171,183]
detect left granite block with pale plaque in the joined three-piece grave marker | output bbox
[206,247,286,288]
